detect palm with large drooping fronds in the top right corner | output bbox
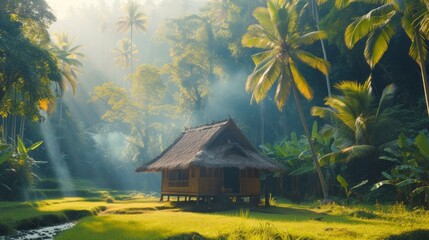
[337,0,429,116]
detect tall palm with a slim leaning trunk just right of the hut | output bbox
[242,0,329,200]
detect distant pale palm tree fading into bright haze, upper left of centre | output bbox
[117,0,146,72]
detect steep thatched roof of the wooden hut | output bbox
[136,119,279,172]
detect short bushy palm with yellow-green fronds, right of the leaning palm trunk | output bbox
[312,77,396,149]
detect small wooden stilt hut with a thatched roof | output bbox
[136,119,279,201]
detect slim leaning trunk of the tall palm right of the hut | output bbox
[292,83,329,200]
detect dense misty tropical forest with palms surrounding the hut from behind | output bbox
[0,0,429,206]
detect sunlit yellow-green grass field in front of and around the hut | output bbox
[0,193,429,240]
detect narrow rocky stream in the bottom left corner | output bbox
[0,222,76,240]
